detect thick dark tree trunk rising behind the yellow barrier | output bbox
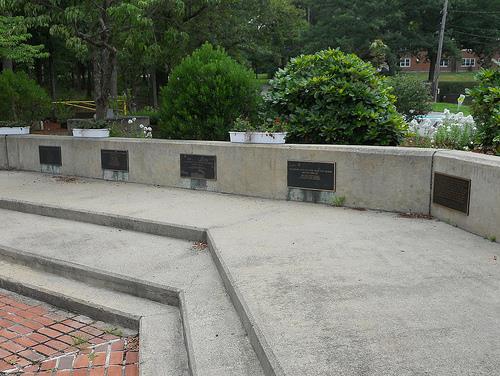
[93,48,116,120]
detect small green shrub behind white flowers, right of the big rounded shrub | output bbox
[388,74,432,121]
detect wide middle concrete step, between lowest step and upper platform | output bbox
[0,210,263,376]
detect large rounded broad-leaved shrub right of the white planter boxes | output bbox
[266,49,405,145]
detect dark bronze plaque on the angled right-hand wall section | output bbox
[432,172,471,215]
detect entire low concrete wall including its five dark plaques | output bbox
[0,135,500,239]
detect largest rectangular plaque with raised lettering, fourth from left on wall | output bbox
[287,161,335,191]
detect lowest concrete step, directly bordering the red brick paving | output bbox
[0,259,189,376]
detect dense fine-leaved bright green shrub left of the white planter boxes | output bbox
[160,43,258,140]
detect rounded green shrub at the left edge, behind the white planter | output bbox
[0,70,51,122]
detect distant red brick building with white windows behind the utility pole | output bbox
[399,50,488,72]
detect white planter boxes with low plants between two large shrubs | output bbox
[229,117,287,144]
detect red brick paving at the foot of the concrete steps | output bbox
[0,290,139,376]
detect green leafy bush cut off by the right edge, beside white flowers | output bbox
[467,68,500,151]
